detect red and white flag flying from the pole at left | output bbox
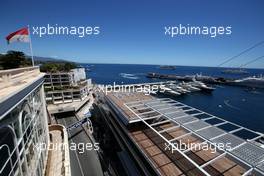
[6,27,29,44]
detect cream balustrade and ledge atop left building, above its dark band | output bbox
[0,67,45,103]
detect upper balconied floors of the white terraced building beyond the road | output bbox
[44,68,89,104]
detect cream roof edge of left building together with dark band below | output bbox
[0,67,45,119]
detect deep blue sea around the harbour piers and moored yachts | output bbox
[82,64,264,133]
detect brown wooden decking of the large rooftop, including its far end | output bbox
[108,93,247,176]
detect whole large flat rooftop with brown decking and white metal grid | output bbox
[107,93,264,176]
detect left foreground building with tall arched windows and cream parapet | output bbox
[0,67,49,176]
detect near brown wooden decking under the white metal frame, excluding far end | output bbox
[130,124,246,176]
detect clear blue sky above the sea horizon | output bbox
[0,0,264,68]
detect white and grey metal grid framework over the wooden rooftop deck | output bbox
[124,98,264,175]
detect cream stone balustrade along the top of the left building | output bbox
[0,66,40,89]
